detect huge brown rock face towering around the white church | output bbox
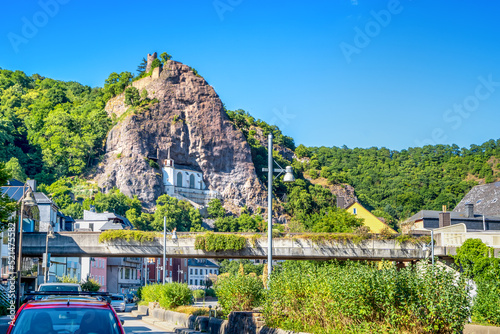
[96,61,265,209]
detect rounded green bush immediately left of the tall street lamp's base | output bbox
[215,274,264,315]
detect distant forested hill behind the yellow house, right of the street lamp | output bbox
[294,140,500,219]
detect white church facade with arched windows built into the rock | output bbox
[162,150,220,206]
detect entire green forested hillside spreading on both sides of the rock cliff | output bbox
[0,64,500,232]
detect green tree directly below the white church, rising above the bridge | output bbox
[151,195,202,232]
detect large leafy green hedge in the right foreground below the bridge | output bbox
[263,261,470,333]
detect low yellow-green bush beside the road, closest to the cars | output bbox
[141,282,193,310]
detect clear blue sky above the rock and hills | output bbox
[0,0,500,150]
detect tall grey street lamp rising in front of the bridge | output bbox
[262,133,295,287]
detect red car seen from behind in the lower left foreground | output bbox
[7,296,125,334]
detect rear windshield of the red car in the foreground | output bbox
[11,307,120,334]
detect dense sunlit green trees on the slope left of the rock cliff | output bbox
[0,70,111,183]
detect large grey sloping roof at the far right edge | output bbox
[453,182,500,216]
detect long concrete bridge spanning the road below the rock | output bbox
[23,232,447,261]
